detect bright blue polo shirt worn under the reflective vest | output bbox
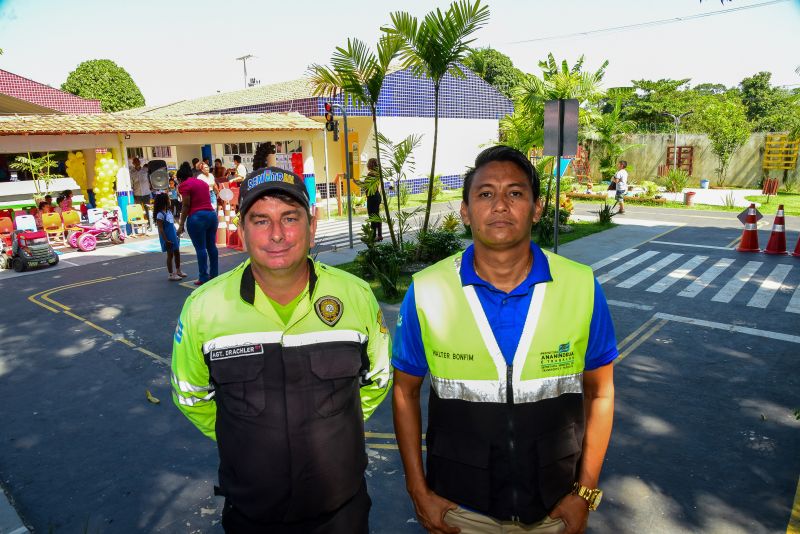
[392,242,619,376]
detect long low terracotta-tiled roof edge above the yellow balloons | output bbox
[0,113,325,136]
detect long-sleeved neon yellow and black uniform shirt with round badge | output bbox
[172,260,391,530]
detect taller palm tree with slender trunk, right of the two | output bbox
[383,0,489,234]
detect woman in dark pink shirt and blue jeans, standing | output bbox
[176,161,219,286]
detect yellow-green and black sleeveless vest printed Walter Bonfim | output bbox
[414,251,594,523]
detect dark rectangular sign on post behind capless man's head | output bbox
[544,99,578,254]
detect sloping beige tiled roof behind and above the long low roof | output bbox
[125,78,313,117]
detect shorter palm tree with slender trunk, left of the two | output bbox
[309,35,403,247]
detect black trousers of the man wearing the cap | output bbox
[222,480,372,534]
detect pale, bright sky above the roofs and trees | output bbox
[0,0,800,105]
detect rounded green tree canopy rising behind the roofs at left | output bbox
[61,59,145,112]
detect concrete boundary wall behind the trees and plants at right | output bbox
[592,133,800,188]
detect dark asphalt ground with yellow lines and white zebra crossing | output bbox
[0,205,800,533]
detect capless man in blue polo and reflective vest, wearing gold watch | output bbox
[392,146,618,534]
